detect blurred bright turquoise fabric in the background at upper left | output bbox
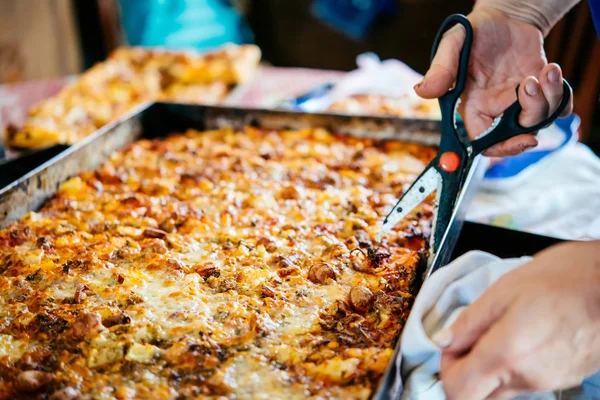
[120,0,253,50]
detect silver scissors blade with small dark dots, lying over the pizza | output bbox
[377,165,442,241]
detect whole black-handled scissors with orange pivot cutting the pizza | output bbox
[378,14,571,254]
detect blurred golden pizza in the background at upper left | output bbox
[5,45,260,149]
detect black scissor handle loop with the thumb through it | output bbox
[431,14,473,105]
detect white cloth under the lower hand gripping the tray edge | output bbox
[393,251,554,400]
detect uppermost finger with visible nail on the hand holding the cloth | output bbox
[432,285,509,354]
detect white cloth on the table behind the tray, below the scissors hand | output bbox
[467,143,600,240]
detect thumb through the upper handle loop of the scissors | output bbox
[415,25,465,99]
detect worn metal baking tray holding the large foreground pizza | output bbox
[0,103,485,399]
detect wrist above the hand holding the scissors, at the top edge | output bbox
[475,0,580,36]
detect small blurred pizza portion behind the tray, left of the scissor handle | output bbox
[328,93,441,119]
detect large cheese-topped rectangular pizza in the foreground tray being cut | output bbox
[0,127,435,400]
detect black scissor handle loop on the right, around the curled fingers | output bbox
[471,79,571,156]
